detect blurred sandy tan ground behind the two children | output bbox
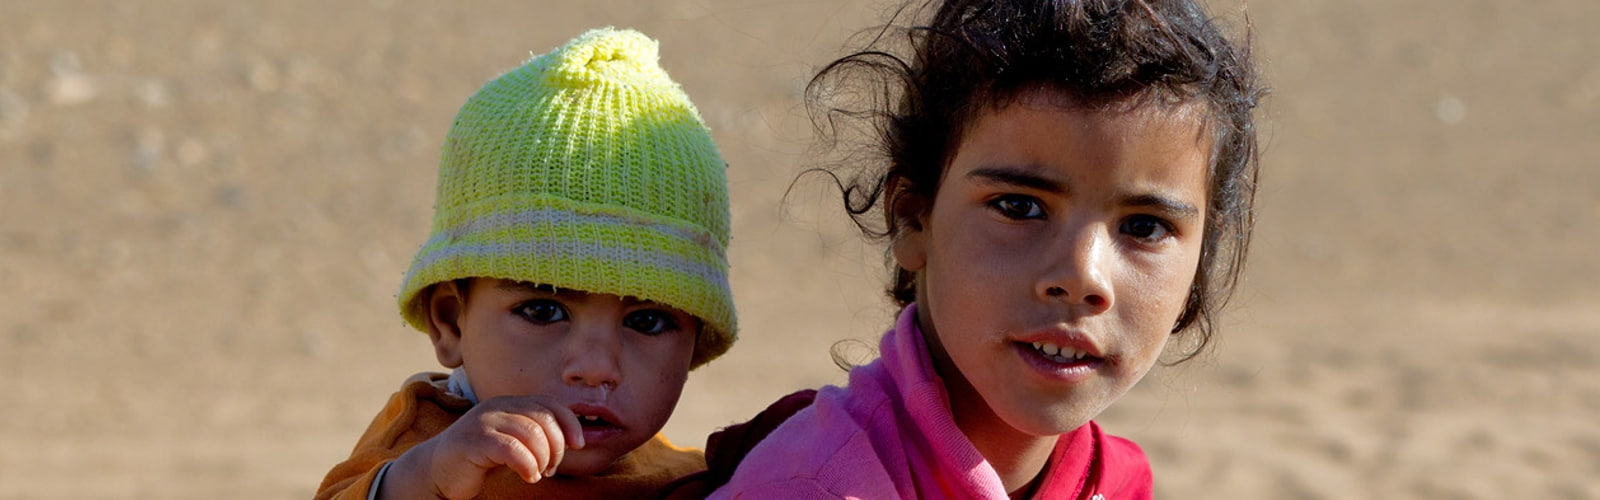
[0,0,1600,498]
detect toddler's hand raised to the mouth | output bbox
[382,396,584,498]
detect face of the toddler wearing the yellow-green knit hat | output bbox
[459,279,701,476]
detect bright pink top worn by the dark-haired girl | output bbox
[710,304,1152,498]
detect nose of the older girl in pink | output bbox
[1035,226,1115,313]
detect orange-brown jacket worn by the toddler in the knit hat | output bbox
[315,373,706,500]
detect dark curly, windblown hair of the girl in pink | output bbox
[806,0,1266,362]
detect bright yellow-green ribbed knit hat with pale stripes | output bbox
[398,27,738,367]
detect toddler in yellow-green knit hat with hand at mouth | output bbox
[317,29,736,498]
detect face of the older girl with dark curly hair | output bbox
[893,91,1210,441]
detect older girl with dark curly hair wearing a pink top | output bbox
[714,0,1262,498]
